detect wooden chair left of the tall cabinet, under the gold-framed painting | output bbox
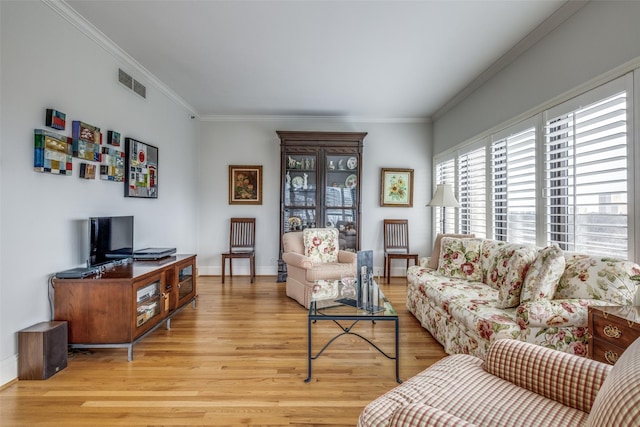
[222,218,256,283]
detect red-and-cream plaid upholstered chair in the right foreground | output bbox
[358,338,640,427]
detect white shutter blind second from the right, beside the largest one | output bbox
[491,126,536,244]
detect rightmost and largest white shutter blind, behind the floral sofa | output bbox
[544,86,628,258]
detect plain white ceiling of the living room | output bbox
[66,0,566,119]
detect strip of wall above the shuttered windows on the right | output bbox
[433,1,640,154]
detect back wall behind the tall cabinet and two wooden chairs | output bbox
[198,118,432,275]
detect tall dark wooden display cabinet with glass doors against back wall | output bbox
[277,131,367,282]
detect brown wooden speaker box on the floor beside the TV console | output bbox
[18,321,69,380]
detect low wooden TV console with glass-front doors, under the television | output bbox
[53,255,196,360]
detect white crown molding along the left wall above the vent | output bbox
[41,0,197,116]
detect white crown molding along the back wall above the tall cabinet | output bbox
[199,115,431,123]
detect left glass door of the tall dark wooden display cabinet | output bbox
[283,154,318,233]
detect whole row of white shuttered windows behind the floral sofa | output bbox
[434,73,640,259]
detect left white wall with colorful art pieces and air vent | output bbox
[0,1,199,384]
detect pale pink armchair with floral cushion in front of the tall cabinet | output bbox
[282,228,357,308]
